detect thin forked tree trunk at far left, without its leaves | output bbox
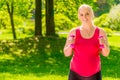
[7,1,17,39]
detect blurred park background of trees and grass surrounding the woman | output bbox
[0,0,120,80]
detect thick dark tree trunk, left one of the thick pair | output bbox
[35,0,42,36]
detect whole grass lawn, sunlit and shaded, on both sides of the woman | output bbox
[0,35,120,80]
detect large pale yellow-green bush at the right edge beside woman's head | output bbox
[94,4,120,30]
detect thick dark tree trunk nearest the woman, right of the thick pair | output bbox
[46,0,55,36]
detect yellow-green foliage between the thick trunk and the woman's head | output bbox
[54,0,96,21]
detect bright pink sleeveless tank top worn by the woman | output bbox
[70,27,101,77]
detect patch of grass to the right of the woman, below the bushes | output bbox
[101,35,120,80]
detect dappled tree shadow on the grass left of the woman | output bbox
[0,37,70,76]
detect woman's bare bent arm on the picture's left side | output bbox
[63,29,75,57]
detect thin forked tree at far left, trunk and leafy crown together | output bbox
[0,0,33,39]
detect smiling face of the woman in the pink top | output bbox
[78,7,93,24]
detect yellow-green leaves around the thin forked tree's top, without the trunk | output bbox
[0,0,35,18]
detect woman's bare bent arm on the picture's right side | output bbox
[100,29,110,57]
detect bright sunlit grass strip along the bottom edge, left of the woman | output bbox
[0,73,67,80]
